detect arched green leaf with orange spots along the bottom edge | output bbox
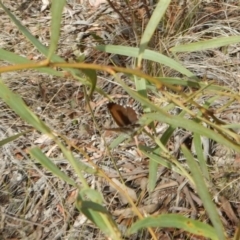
[128,214,218,240]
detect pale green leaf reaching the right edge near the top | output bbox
[170,36,240,52]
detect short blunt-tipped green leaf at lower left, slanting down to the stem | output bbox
[29,147,77,187]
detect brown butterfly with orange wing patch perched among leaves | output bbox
[107,102,140,130]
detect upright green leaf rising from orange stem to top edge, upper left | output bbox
[47,0,66,61]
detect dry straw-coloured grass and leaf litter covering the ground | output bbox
[0,0,240,239]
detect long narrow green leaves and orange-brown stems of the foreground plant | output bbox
[0,0,240,239]
